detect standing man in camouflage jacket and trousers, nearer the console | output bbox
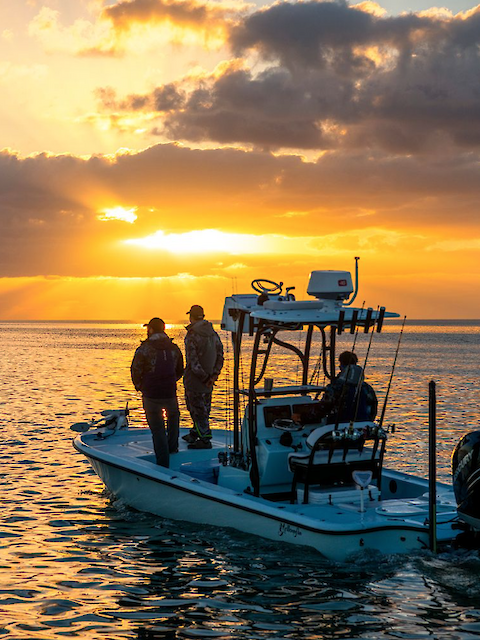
[183,304,223,449]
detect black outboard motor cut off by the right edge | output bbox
[452,431,480,531]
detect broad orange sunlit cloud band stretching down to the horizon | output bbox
[0,145,480,318]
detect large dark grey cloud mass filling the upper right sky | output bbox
[91,1,480,154]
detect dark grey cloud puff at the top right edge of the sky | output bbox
[230,1,458,70]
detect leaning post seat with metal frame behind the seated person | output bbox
[288,422,386,504]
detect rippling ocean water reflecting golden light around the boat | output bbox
[0,321,480,640]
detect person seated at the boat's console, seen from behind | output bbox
[321,351,378,424]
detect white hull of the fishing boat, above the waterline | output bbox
[75,430,455,562]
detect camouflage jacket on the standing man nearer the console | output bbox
[183,320,223,393]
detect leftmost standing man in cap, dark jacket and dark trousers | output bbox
[130,318,184,467]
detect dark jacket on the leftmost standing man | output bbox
[130,333,184,398]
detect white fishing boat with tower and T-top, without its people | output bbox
[72,259,459,562]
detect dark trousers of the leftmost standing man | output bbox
[143,396,180,467]
